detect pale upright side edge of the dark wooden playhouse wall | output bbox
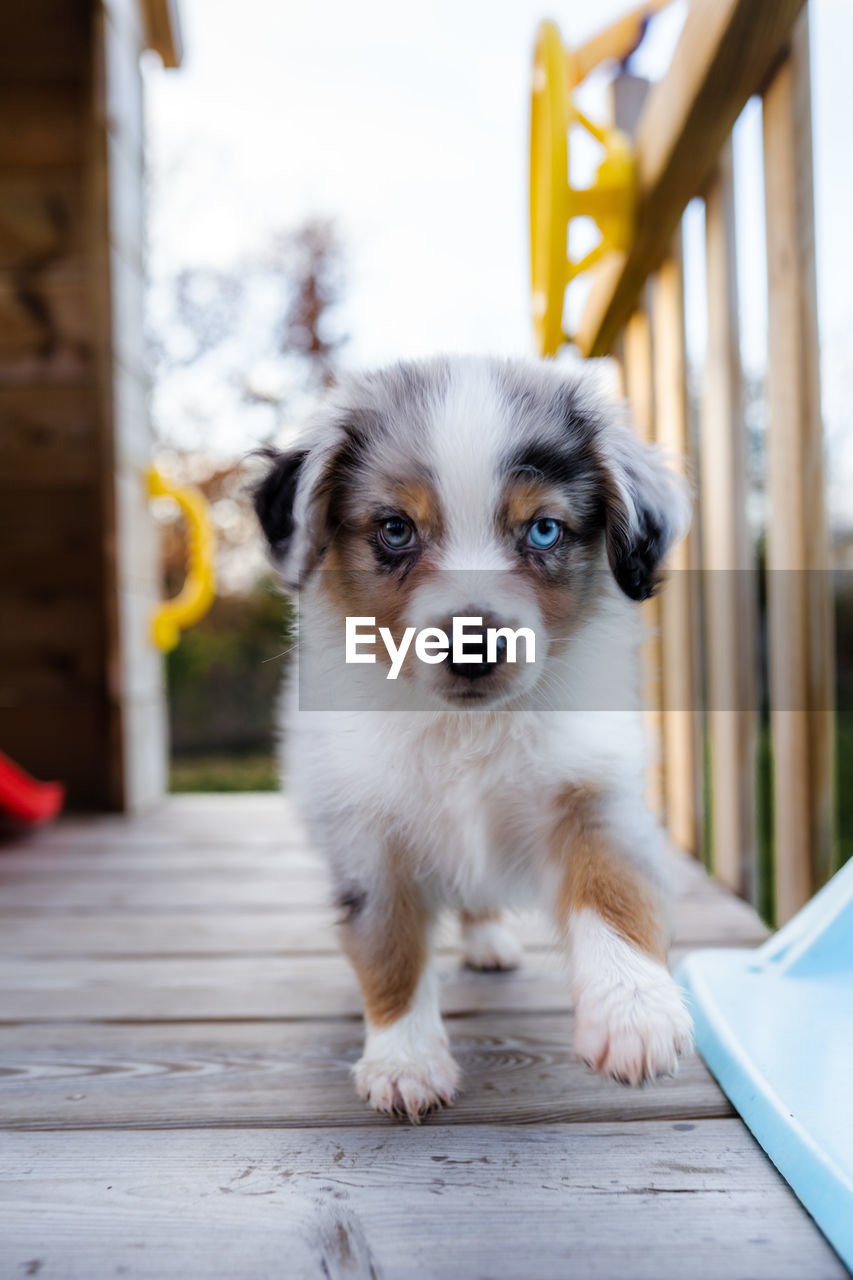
[88,5,168,810]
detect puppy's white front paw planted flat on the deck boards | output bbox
[352,1043,460,1124]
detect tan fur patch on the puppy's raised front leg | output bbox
[552,786,666,964]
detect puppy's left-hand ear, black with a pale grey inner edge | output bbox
[254,443,343,591]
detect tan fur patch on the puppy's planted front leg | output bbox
[339,858,427,1027]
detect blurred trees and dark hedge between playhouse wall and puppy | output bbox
[149,220,346,768]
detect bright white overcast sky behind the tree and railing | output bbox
[146,0,853,519]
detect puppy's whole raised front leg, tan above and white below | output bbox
[555,795,693,1084]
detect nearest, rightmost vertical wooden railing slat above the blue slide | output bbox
[763,10,834,923]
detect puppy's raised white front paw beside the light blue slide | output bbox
[575,960,693,1084]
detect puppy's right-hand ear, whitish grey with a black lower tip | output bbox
[601,422,690,600]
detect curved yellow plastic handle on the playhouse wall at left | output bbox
[147,467,216,653]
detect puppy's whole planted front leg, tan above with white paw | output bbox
[341,878,460,1124]
